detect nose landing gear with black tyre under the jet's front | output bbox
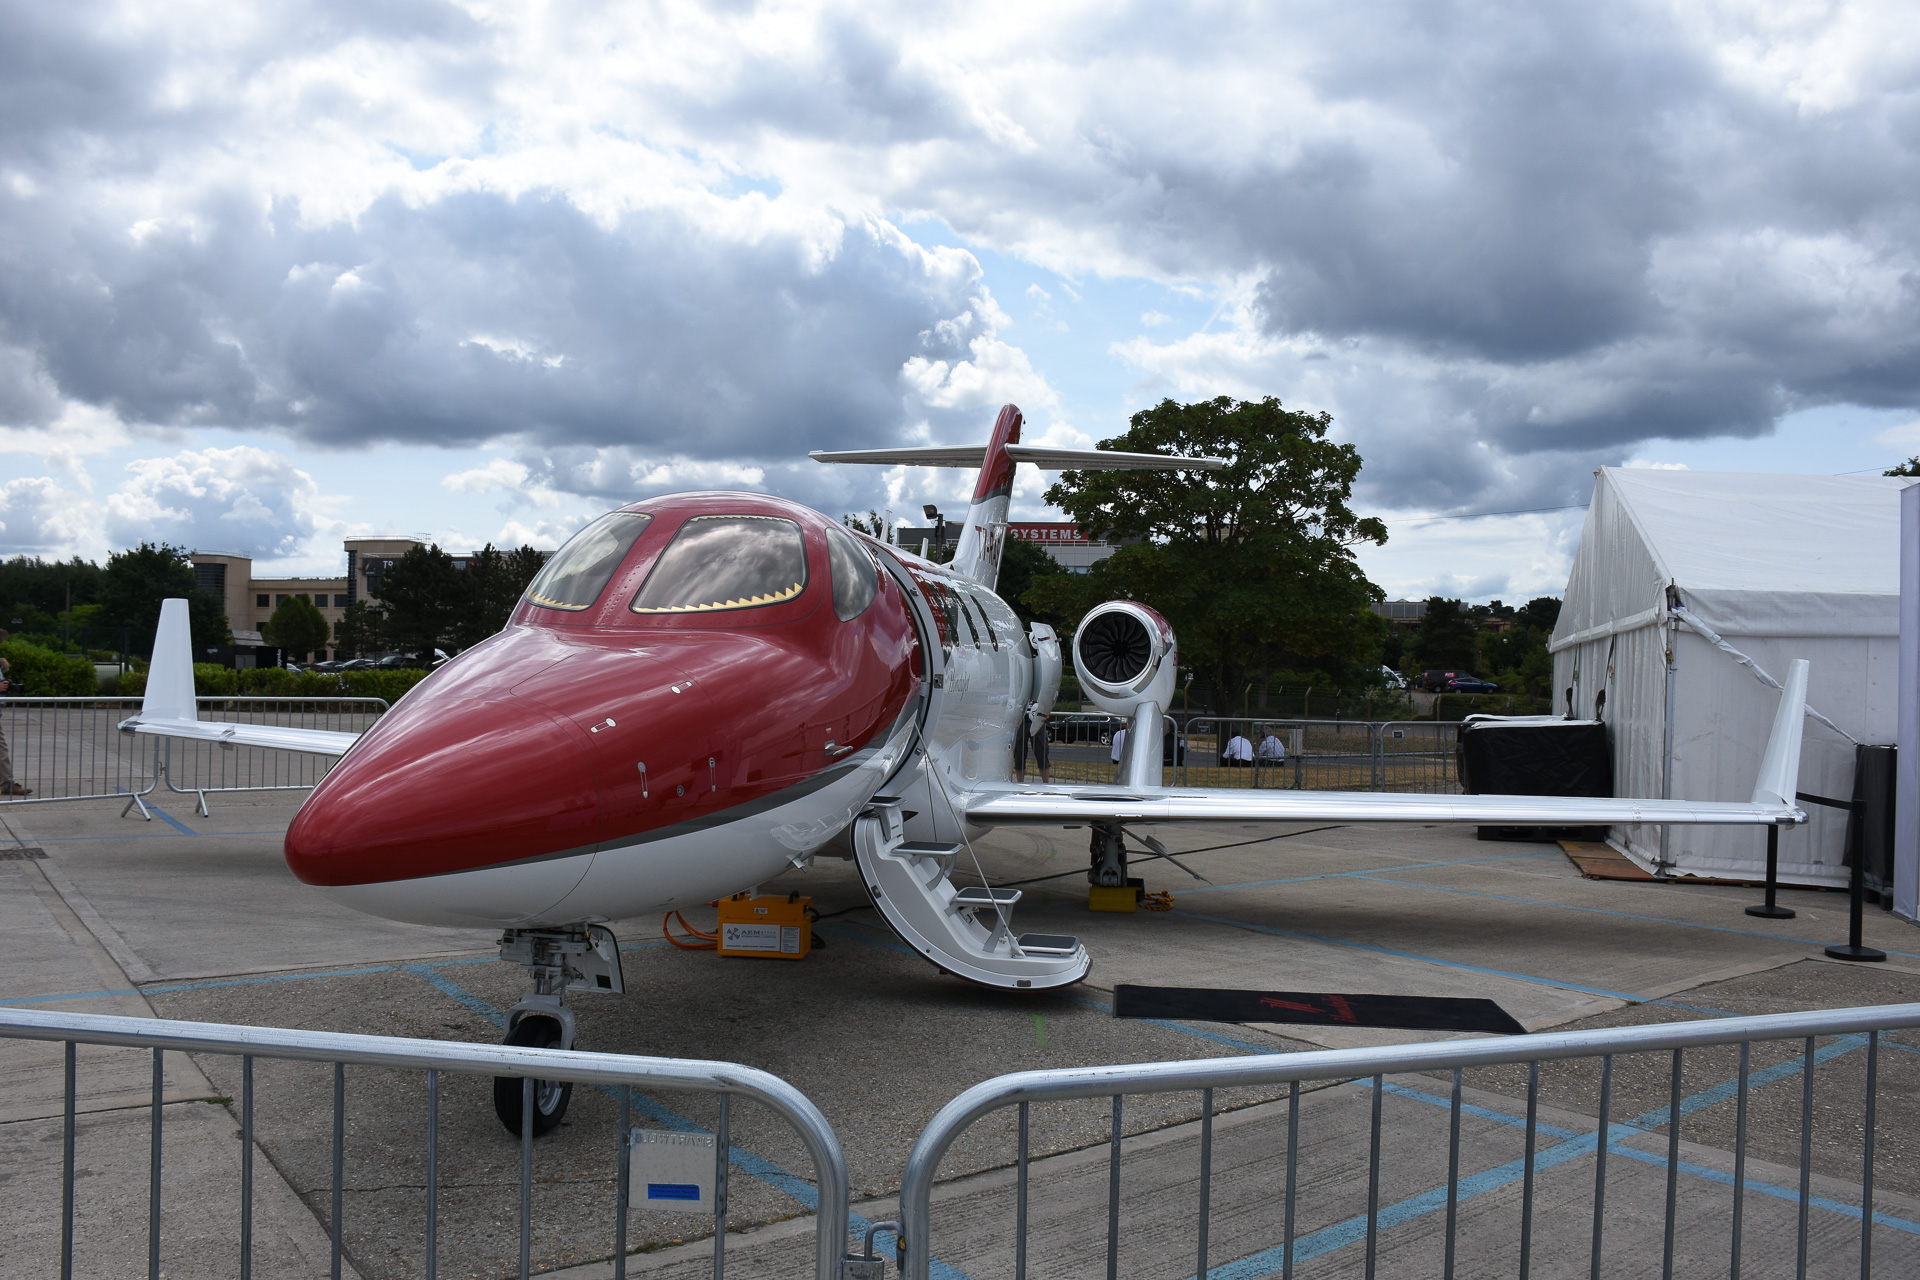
[493,925,626,1138]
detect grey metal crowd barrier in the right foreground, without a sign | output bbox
[900,1004,1920,1280]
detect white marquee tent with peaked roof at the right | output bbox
[1549,466,1910,885]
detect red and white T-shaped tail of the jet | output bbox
[808,405,1227,591]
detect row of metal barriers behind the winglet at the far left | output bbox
[0,697,388,812]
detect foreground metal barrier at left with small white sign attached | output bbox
[0,1007,849,1280]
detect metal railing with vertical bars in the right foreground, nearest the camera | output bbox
[900,1004,1920,1280]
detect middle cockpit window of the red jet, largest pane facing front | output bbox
[632,516,806,614]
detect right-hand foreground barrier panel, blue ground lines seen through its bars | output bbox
[900,1004,1920,1280]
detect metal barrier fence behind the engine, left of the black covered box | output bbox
[1048,712,1459,794]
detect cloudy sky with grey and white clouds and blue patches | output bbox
[0,0,1920,599]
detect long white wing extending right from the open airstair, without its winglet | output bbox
[966,785,1807,827]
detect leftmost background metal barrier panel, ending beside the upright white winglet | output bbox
[0,699,156,804]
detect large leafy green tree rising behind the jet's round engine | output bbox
[1023,395,1386,710]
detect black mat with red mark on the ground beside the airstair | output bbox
[1114,983,1526,1036]
